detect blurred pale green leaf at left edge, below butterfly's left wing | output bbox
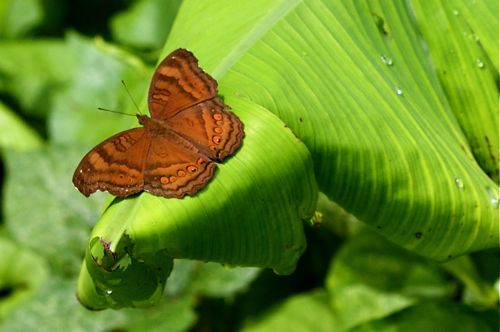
[3,146,103,275]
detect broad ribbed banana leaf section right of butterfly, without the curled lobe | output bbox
[164,0,499,260]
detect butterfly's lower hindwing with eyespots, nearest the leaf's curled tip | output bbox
[144,130,215,198]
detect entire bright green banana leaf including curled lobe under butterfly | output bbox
[79,0,499,308]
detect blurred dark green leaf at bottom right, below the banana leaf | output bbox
[326,231,454,329]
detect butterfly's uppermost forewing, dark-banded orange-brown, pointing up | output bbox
[148,49,217,120]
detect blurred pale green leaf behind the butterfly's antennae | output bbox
[49,34,151,145]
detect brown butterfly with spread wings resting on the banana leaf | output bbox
[73,49,244,198]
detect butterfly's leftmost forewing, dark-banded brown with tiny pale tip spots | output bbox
[73,128,151,197]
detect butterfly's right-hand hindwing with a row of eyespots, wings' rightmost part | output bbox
[169,97,244,161]
